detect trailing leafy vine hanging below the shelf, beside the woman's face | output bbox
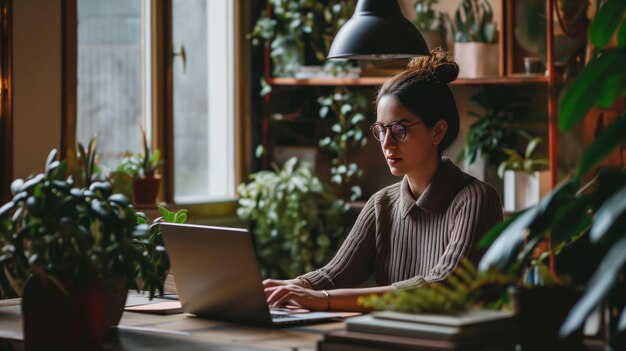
[317,88,367,201]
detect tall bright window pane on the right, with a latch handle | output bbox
[172,0,235,202]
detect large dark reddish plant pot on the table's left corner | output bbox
[22,274,128,351]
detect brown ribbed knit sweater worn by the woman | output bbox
[301,159,502,290]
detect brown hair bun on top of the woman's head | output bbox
[407,48,459,84]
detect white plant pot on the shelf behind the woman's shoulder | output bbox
[504,171,550,212]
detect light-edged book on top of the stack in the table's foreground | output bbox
[346,310,515,340]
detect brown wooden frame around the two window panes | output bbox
[61,0,249,218]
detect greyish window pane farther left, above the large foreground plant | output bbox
[77,0,149,169]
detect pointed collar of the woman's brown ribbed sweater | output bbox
[400,158,462,218]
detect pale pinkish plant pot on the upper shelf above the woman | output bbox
[454,42,499,78]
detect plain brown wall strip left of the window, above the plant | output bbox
[13,0,62,178]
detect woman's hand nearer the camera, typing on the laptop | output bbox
[265,284,328,311]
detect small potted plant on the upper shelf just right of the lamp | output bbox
[413,0,446,50]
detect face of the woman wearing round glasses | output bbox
[376,95,447,176]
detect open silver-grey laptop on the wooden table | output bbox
[156,223,341,326]
